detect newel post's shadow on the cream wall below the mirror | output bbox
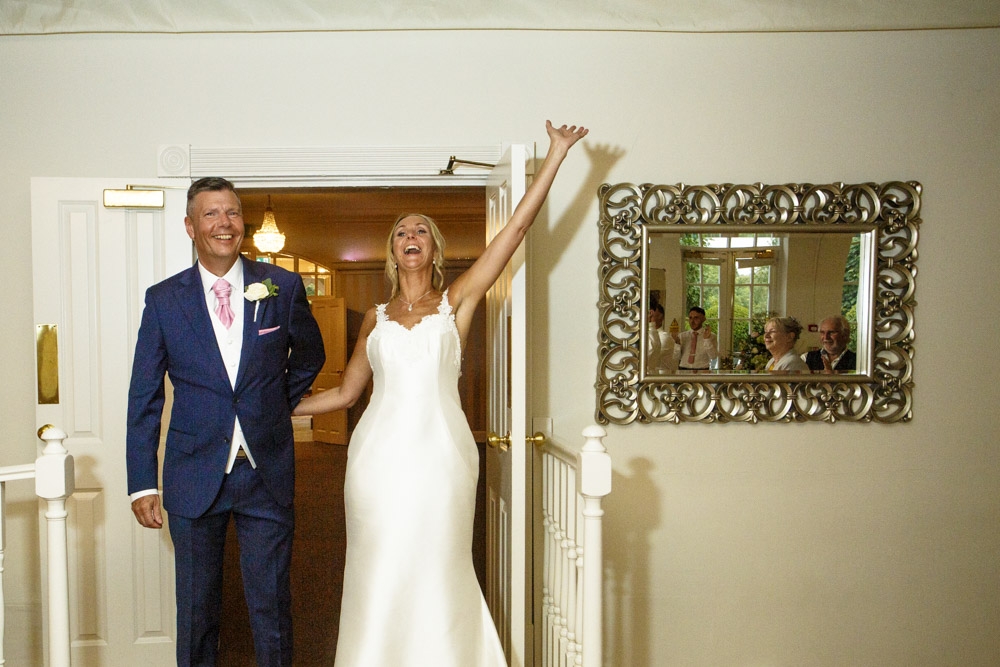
[604,457,660,667]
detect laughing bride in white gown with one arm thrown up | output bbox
[295,121,587,667]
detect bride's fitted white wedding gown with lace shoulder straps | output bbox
[335,291,507,667]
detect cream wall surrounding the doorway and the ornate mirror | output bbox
[0,30,1000,667]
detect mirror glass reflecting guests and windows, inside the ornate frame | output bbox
[643,226,874,380]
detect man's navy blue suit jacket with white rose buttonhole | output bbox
[126,257,325,518]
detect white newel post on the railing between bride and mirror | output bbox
[579,425,611,667]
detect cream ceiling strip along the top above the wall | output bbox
[0,0,1000,35]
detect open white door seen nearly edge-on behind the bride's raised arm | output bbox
[486,145,533,667]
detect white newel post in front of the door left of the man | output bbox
[35,426,76,667]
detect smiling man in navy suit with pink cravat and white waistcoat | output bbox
[126,178,325,666]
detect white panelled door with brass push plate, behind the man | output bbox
[31,178,193,667]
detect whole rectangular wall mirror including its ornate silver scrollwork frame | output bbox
[596,181,922,423]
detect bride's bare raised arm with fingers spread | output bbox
[448,121,589,321]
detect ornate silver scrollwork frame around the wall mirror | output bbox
[596,181,922,424]
